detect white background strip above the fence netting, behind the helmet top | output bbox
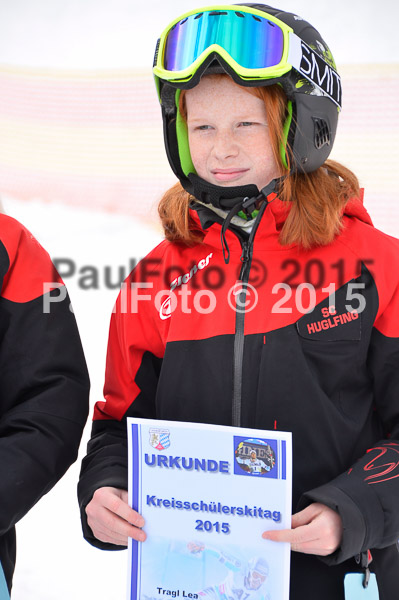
[0,0,399,68]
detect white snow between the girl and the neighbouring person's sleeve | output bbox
[3,198,161,600]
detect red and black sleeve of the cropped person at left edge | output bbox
[0,215,89,535]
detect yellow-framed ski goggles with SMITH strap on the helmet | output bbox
[153,5,341,106]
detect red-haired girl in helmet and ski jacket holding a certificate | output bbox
[79,4,399,600]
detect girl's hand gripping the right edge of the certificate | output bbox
[262,502,343,556]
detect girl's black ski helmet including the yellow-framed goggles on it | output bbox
[153,4,342,198]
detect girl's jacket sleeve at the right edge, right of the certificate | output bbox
[300,272,399,564]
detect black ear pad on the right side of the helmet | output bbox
[288,93,338,173]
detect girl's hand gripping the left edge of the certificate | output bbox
[86,487,147,546]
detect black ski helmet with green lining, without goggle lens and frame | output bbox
[154,3,342,203]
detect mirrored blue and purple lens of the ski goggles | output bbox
[163,10,284,71]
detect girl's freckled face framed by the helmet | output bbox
[186,76,279,190]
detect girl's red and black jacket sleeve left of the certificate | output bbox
[78,264,164,550]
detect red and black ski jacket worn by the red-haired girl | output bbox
[79,193,399,600]
